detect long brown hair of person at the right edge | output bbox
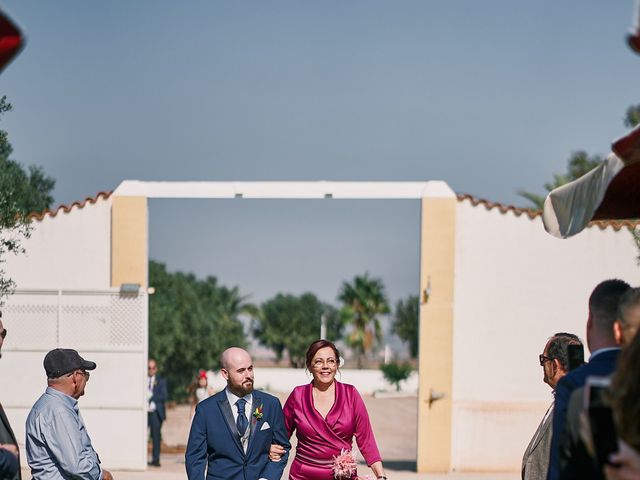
[611,334,640,450]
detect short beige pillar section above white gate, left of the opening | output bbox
[111,196,149,289]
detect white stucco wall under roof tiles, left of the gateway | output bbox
[5,197,111,290]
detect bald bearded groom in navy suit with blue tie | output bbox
[185,347,291,480]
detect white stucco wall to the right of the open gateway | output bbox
[450,200,640,471]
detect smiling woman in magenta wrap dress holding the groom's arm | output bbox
[272,340,387,480]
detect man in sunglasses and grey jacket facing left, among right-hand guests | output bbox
[522,332,582,480]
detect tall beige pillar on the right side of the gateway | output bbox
[417,188,457,473]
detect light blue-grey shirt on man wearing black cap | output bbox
[26,387,102,480]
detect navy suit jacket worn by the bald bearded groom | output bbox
[185,390,291,480]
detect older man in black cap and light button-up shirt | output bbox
[26,348,113,480]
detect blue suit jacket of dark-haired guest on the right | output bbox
[547,349,620,480]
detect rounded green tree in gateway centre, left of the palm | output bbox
[253,293,343,368]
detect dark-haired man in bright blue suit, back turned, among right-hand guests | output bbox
[547,280,631,480]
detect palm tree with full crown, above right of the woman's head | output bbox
[338,273,389,368]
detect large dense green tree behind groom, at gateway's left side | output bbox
[149,260,256,400]
